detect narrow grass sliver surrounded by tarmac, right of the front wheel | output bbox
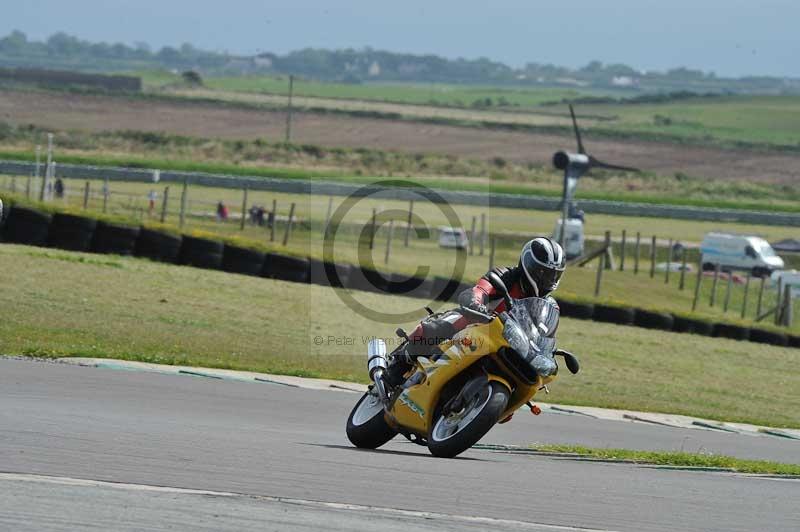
[531,445,800,476]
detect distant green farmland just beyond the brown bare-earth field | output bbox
[143,72,800,150]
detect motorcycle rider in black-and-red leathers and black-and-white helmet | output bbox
[388,236,567,385]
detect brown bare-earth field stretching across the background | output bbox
[0,91,800,184]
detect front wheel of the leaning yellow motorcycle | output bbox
[428,382,511,458]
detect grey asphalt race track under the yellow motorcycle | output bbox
[0,360,800,531]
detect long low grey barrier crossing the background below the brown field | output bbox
[0,161,800,227]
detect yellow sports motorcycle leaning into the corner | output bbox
[347,274,579,458]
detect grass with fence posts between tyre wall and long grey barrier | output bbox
[6,191,800,334]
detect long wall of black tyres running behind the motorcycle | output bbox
[2,206,800,347]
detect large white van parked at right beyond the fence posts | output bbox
[700,233,783,276]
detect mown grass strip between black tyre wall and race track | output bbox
[0,245,800,427]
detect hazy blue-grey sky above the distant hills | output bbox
[0,0,800,77]
